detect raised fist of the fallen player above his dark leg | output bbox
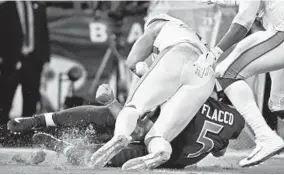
[96,84,114,105]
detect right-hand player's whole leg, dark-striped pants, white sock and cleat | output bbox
[216,32,284,166]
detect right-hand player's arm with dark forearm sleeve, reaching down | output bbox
[217,0,260,55]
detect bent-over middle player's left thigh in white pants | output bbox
[126,44,193,113]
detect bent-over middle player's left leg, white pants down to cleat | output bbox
[89,44,202,167]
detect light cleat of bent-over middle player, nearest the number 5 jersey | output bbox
[122,152,170,170]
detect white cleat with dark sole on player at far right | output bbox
[239,134,284,167]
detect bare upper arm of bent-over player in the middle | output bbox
[126,22,164,73]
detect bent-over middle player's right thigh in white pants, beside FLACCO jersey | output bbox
[145,78,214,143]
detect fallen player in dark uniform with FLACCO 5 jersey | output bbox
[8,85,245,170]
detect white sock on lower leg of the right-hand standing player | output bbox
[225,81,272,139]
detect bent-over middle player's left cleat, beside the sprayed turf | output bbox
[89,135,131,168]
